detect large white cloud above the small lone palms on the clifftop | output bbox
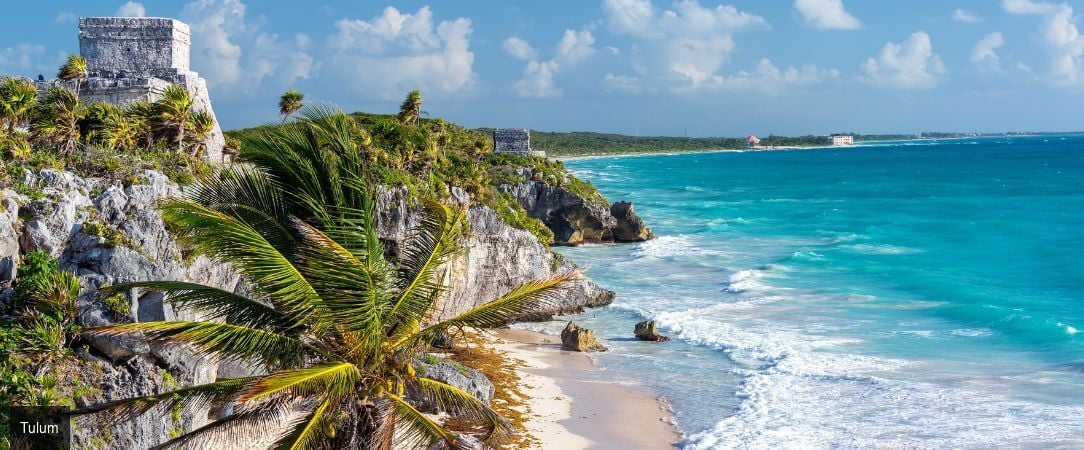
[326,7,475,99]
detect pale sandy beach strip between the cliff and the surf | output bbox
[485,329,681,450]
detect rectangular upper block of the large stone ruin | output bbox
[79,17,192,74]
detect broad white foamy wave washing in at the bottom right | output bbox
[656,310,1084,449]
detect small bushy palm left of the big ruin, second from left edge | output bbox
[30,86,83,155]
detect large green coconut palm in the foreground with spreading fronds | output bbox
[80,110,575,449]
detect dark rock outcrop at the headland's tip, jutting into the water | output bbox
[501,175,655,245]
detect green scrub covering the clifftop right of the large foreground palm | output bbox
[227,113,609,245]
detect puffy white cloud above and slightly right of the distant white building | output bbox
[861,31,945,89]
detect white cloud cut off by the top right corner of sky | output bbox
[1002,0,1084,86]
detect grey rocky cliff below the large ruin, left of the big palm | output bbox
[0,169,241,449]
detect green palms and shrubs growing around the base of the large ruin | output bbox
[0,56,215,189]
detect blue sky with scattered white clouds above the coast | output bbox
[0,0,1084,137]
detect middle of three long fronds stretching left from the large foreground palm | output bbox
[82,321,305,368]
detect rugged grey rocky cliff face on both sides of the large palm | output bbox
[0,169,614,449]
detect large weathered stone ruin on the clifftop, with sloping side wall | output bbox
[38,17,225,163]
